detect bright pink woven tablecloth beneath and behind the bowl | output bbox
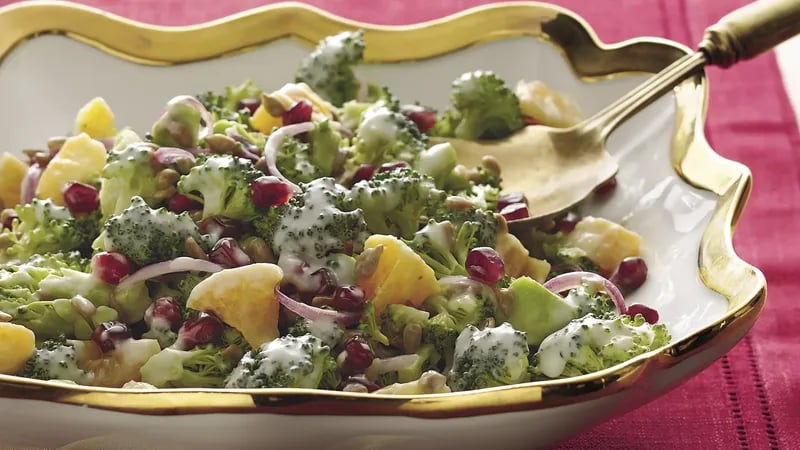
[0,0,800,449]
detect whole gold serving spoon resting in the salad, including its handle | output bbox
[444,0,800,229]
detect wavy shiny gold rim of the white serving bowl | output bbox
[0,2,766,418]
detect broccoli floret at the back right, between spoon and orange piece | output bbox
[433,71,525,140]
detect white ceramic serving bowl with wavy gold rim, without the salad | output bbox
[0,3,766,450]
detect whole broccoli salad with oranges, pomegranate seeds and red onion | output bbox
[0,31,671,395]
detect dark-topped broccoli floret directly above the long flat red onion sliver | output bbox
[99,197,208,266]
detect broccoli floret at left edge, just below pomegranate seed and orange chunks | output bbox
[0,199,100,261]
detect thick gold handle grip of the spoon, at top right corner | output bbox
[700,0,800,67]
